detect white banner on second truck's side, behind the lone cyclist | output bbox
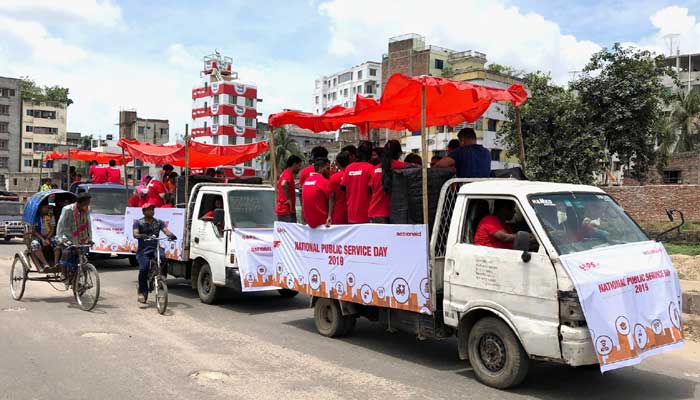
[122,207,185,261]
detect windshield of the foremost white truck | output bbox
[529,193,648,255]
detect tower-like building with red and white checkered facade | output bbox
[190,52,262,176]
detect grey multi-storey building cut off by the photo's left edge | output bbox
[0,77,22,180]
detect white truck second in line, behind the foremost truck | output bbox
[168,183,297,304]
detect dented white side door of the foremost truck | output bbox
[445,196,561,358]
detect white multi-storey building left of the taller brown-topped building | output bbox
[313,61,382,114]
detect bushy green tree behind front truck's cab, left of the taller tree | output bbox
[498,71,604,184]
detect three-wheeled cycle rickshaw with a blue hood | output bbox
[10,189,100,311]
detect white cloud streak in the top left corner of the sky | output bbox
[0,16,88,65]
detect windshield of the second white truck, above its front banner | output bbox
[228,190,275,228]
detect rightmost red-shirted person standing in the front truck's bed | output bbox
[368,140,406,224]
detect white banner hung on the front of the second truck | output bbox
[231,228,280,292]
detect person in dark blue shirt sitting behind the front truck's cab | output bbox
[433,128,491,178]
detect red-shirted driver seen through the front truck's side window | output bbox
[474,200,515,249]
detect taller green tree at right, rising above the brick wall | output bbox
[571,43,672,184]
